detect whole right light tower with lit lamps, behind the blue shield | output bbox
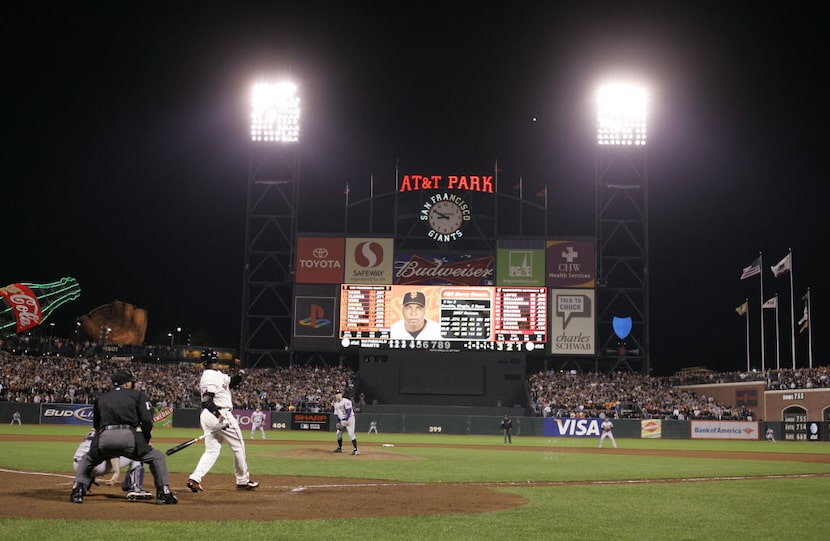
[594,83,651,373]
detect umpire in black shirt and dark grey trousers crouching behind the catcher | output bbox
[69,370,179,505]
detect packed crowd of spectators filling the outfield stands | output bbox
[0,334,830,419]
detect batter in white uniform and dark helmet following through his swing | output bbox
[187,349,259,492]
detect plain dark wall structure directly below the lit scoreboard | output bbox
[358,350,529,408]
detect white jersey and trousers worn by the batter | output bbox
[190,368,250,485]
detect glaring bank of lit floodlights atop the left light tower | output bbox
[251,82,300,143]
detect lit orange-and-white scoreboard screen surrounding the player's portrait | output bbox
[339,284,548,351]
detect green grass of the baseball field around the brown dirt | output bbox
[0,425,830,541]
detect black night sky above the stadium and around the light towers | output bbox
[0,2,830,375]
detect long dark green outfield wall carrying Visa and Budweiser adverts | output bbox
[0,402,830,443]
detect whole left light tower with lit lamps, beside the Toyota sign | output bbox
[239,81,300,368]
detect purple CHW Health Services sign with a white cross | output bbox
[545,238,597,289]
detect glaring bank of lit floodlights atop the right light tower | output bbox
[597,83,648,146]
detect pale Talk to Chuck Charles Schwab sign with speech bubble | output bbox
[548,289,597,355]
